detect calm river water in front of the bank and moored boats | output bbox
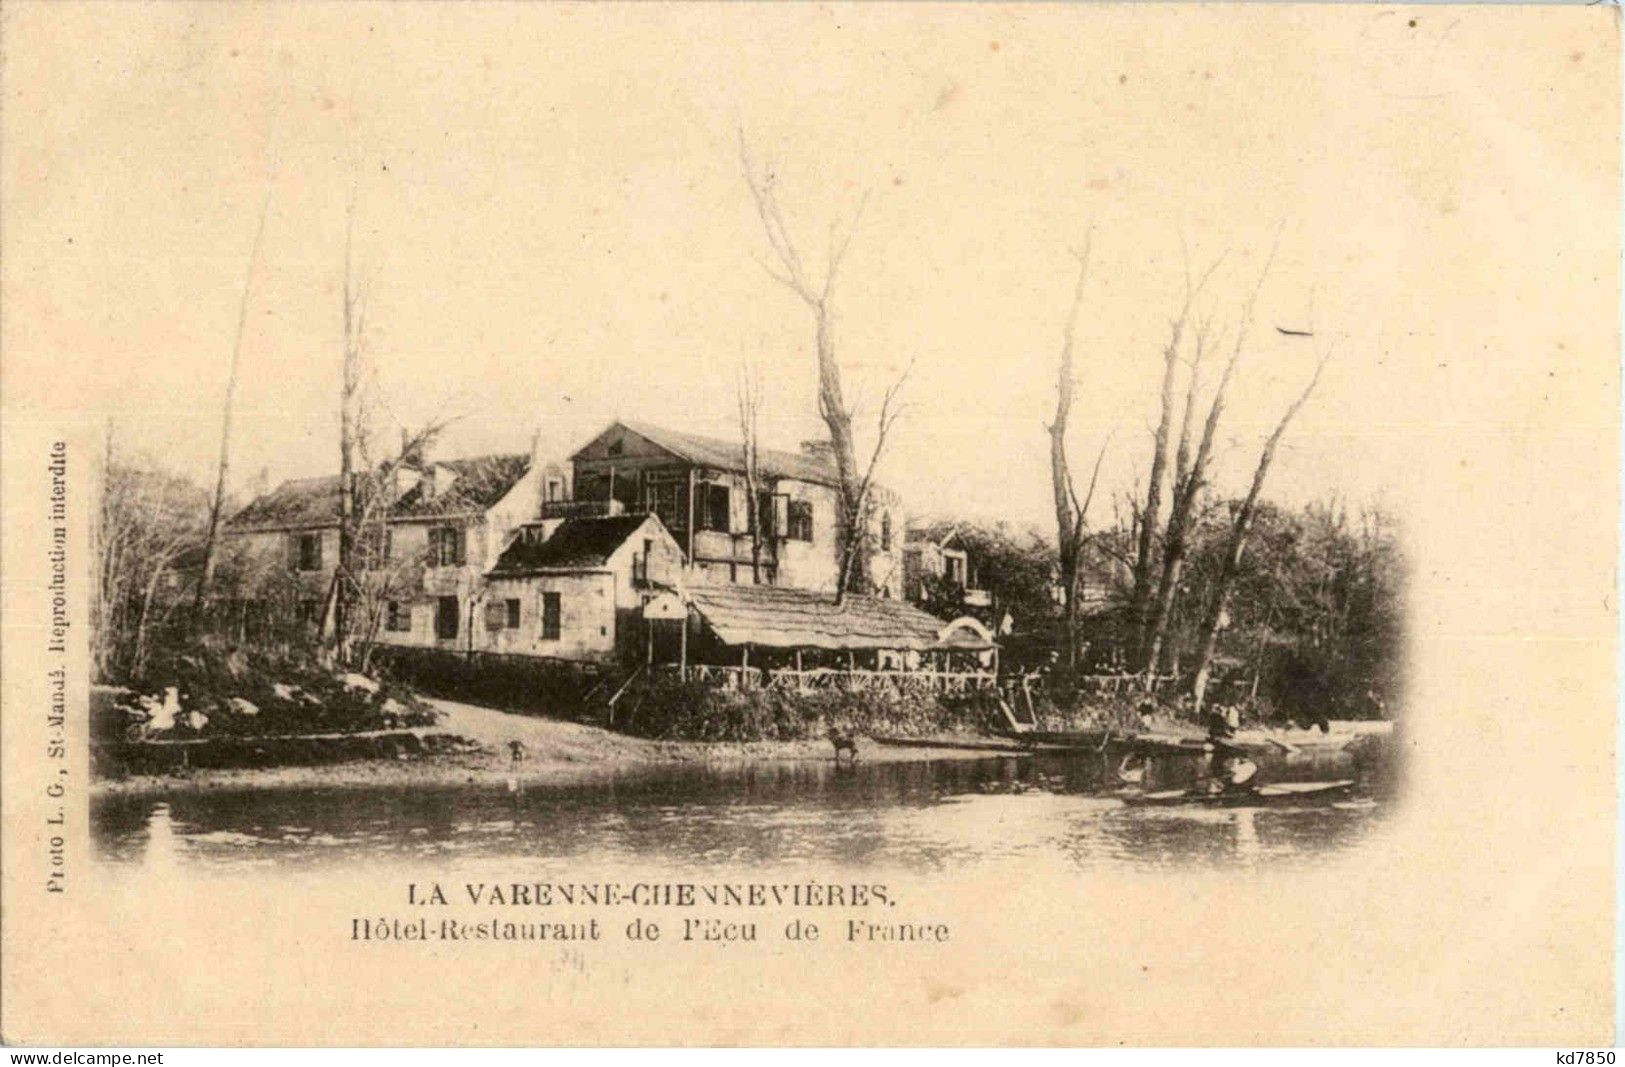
[91,740,1394,872]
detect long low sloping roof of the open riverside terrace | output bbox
[689,585,993,650]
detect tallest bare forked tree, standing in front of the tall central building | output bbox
[739,128,900,601]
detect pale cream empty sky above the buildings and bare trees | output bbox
[3,3,1617,525]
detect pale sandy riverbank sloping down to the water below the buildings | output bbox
[91,698,1020,796]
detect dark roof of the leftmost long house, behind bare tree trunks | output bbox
[226,453,530,531]
